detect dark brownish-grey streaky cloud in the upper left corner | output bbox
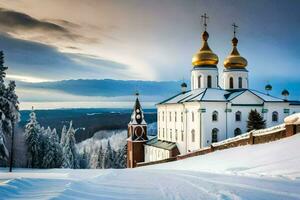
[0,8,97,47]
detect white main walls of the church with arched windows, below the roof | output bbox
[157,89,300,154]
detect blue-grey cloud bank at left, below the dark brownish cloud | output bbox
[0,34,128,80]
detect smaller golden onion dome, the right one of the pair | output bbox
[224,37,248,69]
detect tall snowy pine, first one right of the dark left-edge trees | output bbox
[25,110,41,168]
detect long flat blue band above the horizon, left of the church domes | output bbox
[17,79,185,97]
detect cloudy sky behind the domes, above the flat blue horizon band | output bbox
[0,0,300,109]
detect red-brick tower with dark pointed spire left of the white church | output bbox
[127,93,148,168]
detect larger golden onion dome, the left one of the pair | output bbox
[192,31,219,67]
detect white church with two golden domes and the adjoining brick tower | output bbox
[127,15,300,168]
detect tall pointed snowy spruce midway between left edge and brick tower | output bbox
[62,121,79,169]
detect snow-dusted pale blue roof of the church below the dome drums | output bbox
[158,88,300,105]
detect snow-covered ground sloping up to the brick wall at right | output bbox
[0,134,300,200]
